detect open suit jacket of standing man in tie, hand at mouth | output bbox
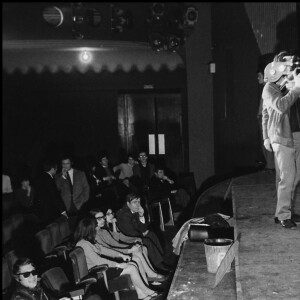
[56,169,90,212]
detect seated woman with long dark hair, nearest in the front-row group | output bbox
[74,217,158,300]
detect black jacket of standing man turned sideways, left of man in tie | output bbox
[36,172,66,222]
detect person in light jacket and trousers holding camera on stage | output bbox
[262,51,300,229]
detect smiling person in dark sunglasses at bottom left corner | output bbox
[11,258,48,300]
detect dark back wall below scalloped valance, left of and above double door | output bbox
[2,69,185,182]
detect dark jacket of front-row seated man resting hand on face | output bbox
[117,203,148,237]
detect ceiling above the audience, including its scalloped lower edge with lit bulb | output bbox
[2,2,184,74]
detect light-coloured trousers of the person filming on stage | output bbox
[272,132,300,220]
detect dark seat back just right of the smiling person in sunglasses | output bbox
[41,267,71,296]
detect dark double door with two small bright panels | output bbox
[118,91,184,174]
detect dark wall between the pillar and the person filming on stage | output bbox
[212,2,298,174]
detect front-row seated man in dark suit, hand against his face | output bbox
[117,193,168,272]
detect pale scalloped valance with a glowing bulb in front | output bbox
[2,40,184,74]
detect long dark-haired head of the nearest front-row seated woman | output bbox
[74,216,97,243]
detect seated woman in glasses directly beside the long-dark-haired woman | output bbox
[90,209,166,282]
